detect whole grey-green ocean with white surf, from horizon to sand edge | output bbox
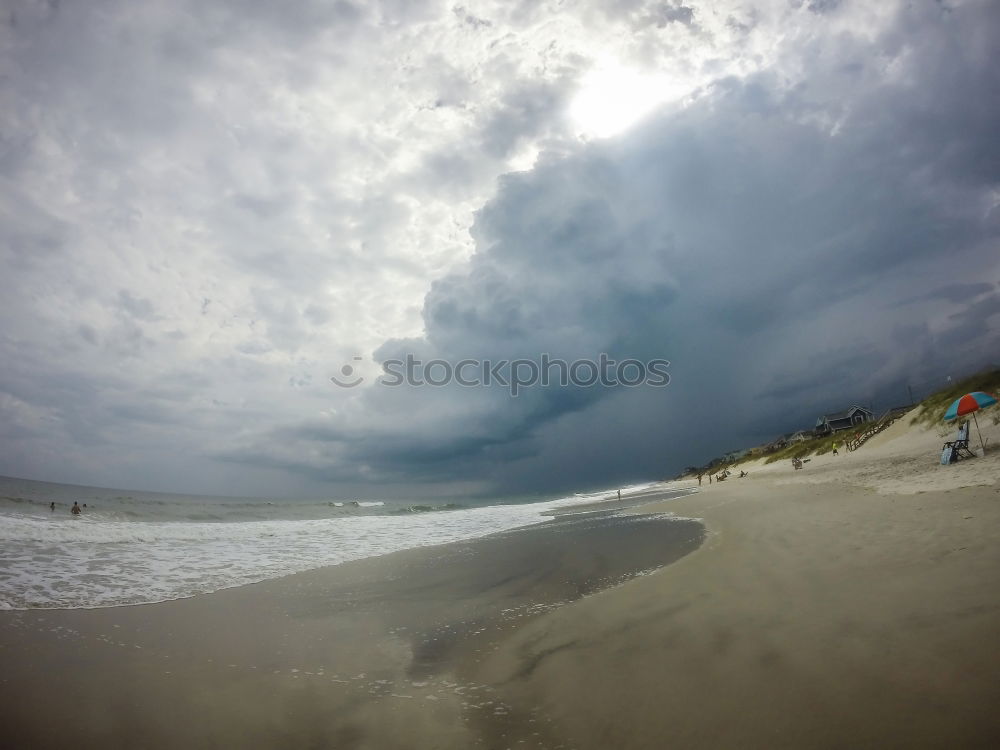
[0,477,683,609]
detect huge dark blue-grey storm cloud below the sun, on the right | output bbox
[240,3,1000,494]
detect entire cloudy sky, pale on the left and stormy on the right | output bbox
[0,0,1000,498]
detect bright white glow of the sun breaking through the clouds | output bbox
[569,62,689,138]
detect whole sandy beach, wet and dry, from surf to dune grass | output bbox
[0,423,1000,749]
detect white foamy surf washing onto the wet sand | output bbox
[0,488,680,609]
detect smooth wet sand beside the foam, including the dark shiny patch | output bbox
[0,514,704,748]
